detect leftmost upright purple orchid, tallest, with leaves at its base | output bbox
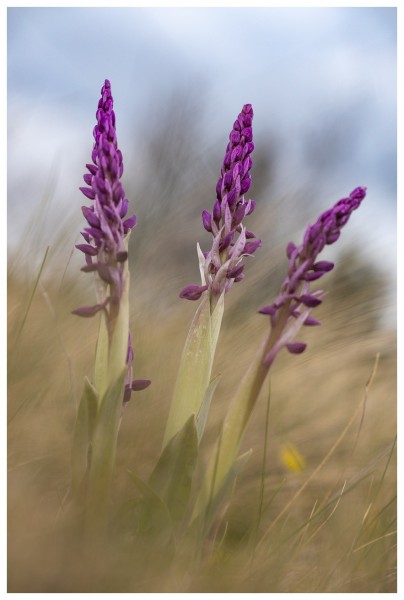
[72,80,150,528]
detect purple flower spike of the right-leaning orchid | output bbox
[259,187,366,364]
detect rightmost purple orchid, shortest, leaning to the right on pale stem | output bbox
[195,187,366,514]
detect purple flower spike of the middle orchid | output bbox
[180,104,261,300]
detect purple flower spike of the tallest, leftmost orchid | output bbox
[73,79,136,316]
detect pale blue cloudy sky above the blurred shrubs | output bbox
[8,8,396,286]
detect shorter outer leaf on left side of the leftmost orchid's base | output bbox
[72,377,98,496]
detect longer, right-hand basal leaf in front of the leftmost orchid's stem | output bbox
[83,369,126,529]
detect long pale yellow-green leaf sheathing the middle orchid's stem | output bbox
[163,294,224,447]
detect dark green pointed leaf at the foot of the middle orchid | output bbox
[149,415,198,523]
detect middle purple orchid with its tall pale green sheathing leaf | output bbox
[163,104,261,447]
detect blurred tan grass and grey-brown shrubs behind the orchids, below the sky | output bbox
[8,98,396,592]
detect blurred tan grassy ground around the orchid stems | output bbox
[8,231,396,592]
